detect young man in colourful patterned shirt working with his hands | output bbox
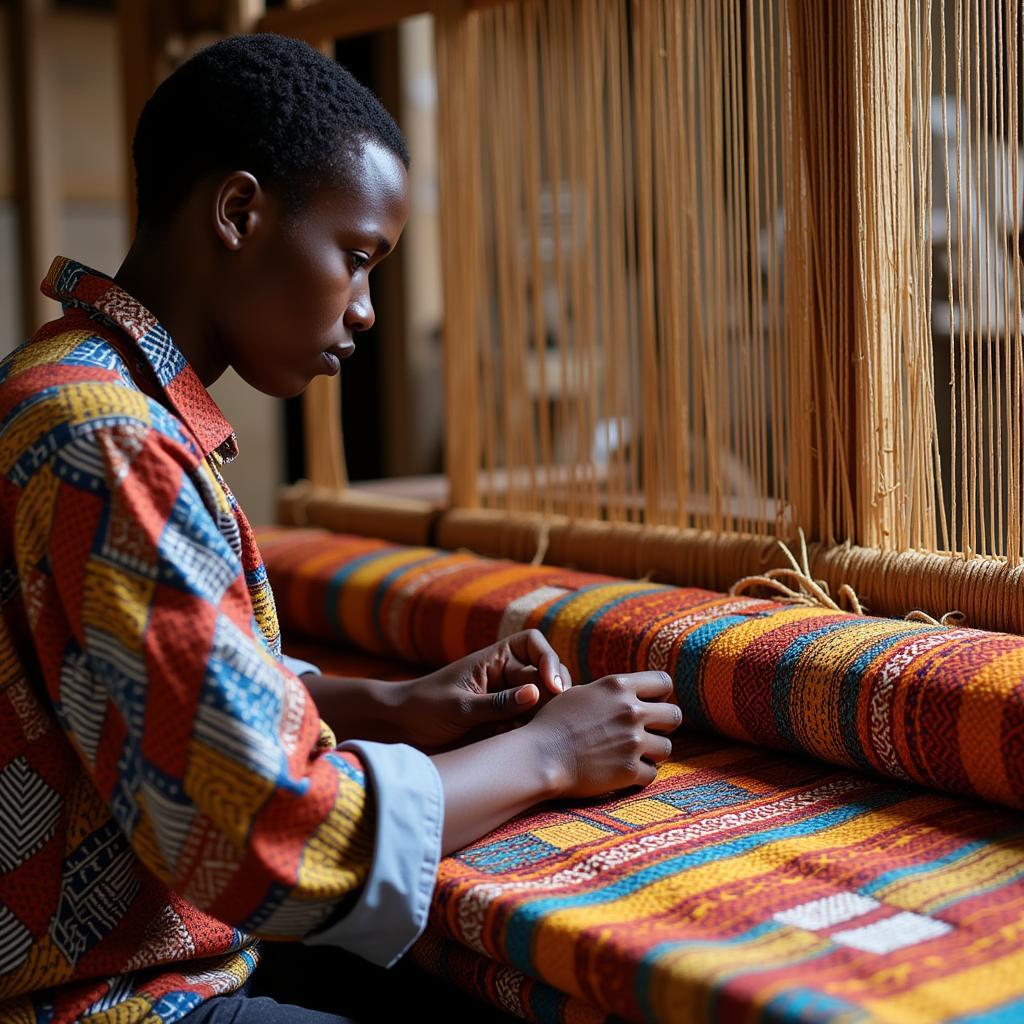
[0,36,680,1024]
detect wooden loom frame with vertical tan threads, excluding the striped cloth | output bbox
[119,0,1024,632]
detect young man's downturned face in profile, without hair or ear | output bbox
[217,142,409,397]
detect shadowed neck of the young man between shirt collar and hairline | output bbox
[114,225,227,387]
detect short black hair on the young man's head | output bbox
[132,35,409,223]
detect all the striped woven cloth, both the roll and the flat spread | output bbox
[260,530,1024,1024]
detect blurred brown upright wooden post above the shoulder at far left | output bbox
[8,0,62,337]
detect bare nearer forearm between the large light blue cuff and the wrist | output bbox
[431,727,564,856]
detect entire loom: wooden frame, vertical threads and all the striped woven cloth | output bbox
[105,9,1024,1024]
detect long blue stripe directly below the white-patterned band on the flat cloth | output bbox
[505,791,906,972]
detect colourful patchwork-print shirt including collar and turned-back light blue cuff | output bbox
[0,259,442,1024]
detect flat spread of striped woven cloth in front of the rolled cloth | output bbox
[414,734,1024,1024]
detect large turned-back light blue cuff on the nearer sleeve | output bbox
[303,739,444,967]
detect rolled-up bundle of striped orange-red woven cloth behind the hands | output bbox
[260,529,1024,807]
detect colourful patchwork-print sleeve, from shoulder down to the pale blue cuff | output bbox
[14,385,439,961]
